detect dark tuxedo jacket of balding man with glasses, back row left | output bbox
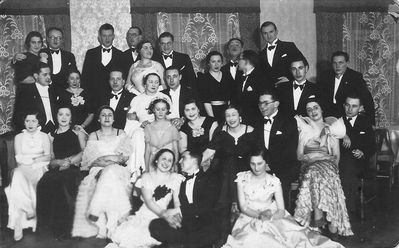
[40,48,76,90]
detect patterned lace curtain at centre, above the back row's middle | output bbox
[157,12,240,73]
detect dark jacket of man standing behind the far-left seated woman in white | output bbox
[14,83,57,131]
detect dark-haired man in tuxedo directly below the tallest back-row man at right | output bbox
[277,57,319,116]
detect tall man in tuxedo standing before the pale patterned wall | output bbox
[82,23,123,111]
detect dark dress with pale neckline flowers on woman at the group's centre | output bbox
[180,117,216,153]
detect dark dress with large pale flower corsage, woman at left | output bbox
[58,90,94,125]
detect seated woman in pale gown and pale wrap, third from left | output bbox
[72,106,132,238]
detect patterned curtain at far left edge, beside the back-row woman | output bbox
[0,15,45,134]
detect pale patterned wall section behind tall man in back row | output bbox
[69,0,131,69]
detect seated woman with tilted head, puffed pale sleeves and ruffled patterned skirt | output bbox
[294,99,353,236]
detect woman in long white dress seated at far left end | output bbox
[4,112,50,241]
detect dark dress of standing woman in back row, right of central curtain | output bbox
[198,72,234,125]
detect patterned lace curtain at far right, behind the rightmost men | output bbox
[343,12,399,127]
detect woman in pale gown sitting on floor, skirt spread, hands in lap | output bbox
[223,149,343,248]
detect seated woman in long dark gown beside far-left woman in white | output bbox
[37,105,86,239]
